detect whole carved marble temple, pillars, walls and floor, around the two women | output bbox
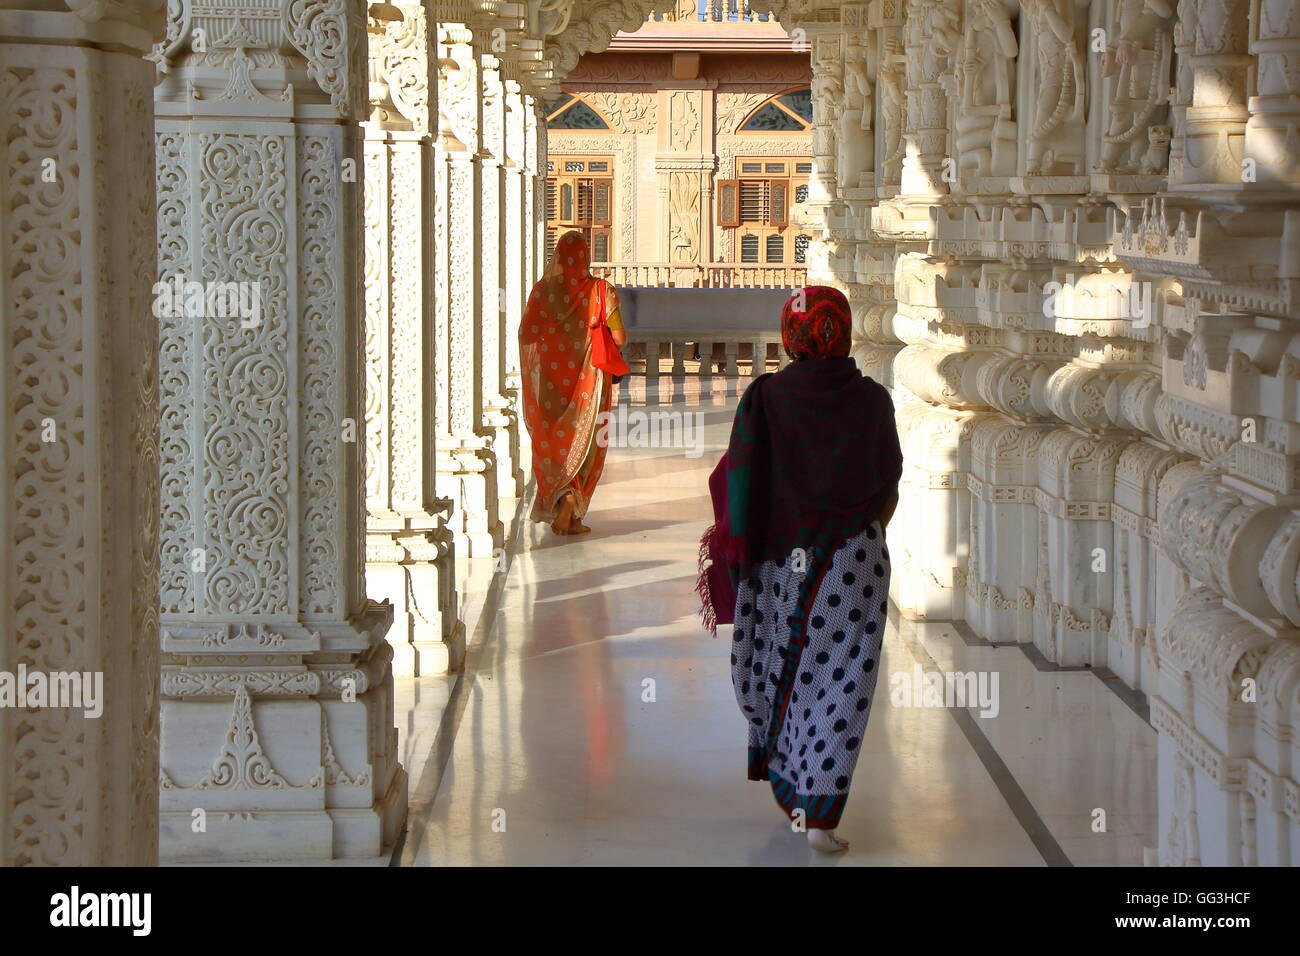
[0,0,1300,866]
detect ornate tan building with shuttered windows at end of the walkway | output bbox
[543,3,813,280]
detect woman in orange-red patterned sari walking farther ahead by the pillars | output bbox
[519,232,627,535]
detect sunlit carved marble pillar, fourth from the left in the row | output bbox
[434,22,502,558]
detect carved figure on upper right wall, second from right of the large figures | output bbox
[1022,0,1087,176]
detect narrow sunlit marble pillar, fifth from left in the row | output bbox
[477,53,519,512]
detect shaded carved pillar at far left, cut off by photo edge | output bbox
[0,0,163,866]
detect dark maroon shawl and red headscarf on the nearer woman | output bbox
[697,286,902,633]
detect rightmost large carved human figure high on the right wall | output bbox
[1100,0,1174,172]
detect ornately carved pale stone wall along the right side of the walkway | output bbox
[847,0,1300,865]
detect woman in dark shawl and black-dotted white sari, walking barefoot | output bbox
[699,286,902,852]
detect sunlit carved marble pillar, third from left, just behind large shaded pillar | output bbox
[364,3,465,676]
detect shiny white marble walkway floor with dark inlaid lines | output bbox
[399,378,1156,866]
